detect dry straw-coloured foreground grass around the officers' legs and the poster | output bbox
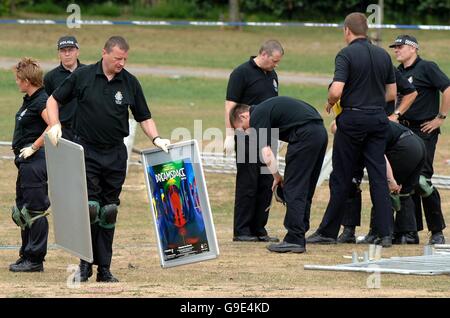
[0,158,450,297]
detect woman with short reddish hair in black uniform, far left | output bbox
[9,58,50,272]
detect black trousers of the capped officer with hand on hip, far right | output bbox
[409,126,445,232]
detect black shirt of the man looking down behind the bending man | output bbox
[226,56,278,105]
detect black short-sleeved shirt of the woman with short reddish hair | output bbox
[12,87,48,149]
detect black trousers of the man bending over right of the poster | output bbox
[283,122,328,246]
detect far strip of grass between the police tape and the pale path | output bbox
[0,25,450,74]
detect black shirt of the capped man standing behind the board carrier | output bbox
[44,60,85,126]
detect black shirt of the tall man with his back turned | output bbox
[333,38,395,109]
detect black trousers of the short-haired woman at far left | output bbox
[14,148,50,263]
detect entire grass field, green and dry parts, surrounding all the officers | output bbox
[0,25,450,297]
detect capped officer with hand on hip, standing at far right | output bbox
[390,35,450,244]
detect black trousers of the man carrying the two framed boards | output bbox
[75,137,128,267]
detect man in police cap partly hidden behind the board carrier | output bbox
[44,36,84,140]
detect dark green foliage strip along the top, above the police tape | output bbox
[0,0,450,24]
